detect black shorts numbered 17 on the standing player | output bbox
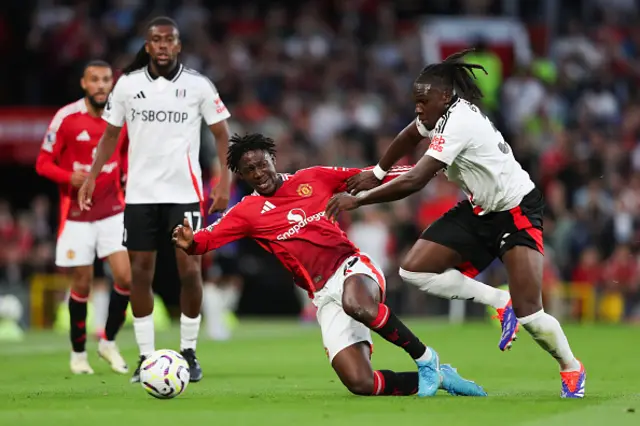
[122,203,204,251]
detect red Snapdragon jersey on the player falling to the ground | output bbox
[190,167,410,292]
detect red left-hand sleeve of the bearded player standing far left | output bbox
[36,108,72,184]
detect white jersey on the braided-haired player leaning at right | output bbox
[416,98,535,215]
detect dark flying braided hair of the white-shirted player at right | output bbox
[415,49,488,101]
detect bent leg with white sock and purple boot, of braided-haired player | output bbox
[400,239,518,350]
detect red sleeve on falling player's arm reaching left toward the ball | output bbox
[189,201,251,255]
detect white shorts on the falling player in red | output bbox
[313,253,386,362]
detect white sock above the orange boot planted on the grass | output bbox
[518,309,580,371]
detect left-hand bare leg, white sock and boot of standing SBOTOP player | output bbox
[129,250,156,383]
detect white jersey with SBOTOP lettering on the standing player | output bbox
[102,64,230,204]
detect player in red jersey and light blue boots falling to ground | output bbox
[173,134,486,396]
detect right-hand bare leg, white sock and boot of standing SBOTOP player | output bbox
[176,249,202,382]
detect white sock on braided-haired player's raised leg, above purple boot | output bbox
[400,268,511,309]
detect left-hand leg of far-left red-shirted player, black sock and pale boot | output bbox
[69,265,93,374]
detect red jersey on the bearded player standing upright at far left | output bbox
[36,99,125,228]
